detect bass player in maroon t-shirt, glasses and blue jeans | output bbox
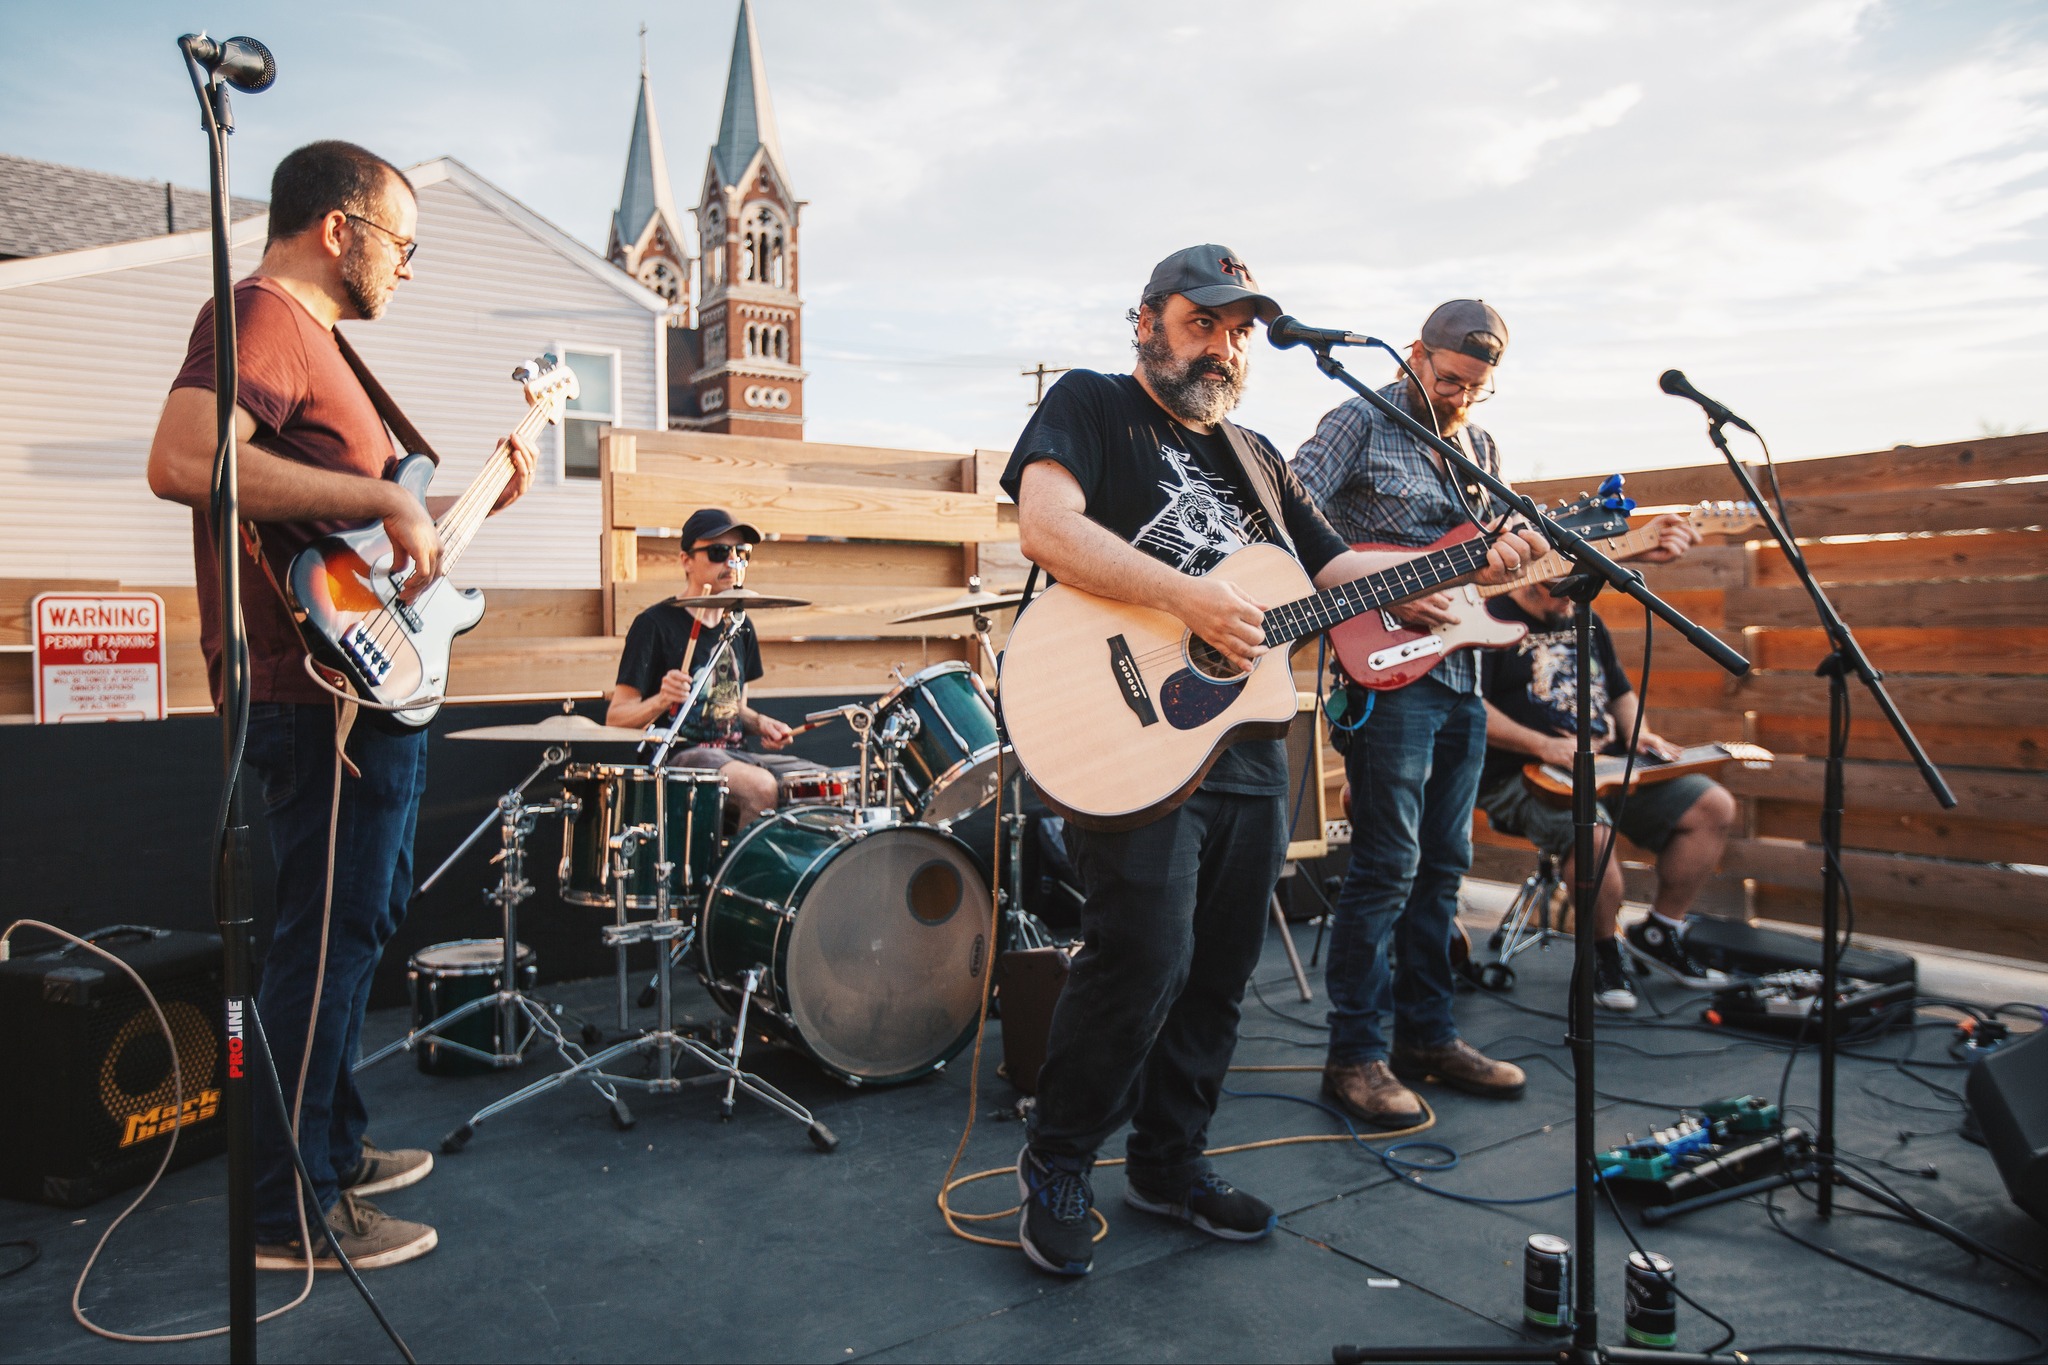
[150,141,532,1271]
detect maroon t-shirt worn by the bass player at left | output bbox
[170,274,397,706]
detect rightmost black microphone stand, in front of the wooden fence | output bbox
[1653,415,1956,1222]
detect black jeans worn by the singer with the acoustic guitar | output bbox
[1030,790,1286,1189]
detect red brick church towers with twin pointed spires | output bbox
[606,0,805,440]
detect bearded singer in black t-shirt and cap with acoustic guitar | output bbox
[1001,246,1544,1275]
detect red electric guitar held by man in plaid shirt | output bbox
[1329,497,1763,692]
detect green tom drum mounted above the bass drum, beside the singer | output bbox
[870,661,1016,825]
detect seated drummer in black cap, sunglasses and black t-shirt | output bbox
[604,508,815,827]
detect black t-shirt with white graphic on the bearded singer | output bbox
[1001,370,1350,796]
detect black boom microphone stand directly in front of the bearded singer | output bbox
[1311,344,1749,1365]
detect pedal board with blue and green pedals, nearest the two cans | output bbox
[1595,1095,1808,1203]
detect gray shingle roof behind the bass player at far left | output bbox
[0,153,268,260]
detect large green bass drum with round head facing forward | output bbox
[696,806,993,1085]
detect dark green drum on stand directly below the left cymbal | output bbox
[559,763,725,911]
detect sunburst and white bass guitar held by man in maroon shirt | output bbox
[285,356,575,726]
